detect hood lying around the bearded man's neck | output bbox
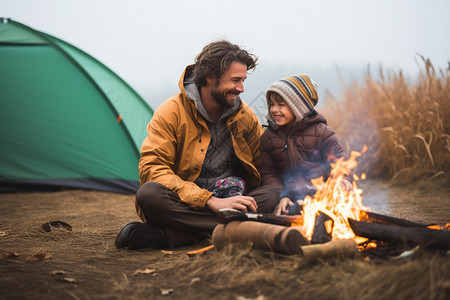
[178,65,242,122]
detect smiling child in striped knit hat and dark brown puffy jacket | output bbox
[260,74,351,214]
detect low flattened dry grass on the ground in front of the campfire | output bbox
[155,247,449,299]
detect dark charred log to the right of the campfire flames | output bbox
[348,218,450,250]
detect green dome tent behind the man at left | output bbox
[0,18,153,193]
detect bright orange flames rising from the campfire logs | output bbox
[302,146,367,243]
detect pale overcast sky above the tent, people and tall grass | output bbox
[0,0,450,108]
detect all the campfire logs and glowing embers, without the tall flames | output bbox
[212,210,450,259]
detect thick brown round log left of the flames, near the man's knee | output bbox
[212,221,309,254]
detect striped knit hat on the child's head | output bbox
[266,74,319,124]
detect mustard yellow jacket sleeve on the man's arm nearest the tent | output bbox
[139,103,212,208]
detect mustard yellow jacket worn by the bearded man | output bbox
[139,66,264,208]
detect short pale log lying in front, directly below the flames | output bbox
[301,239,358,260]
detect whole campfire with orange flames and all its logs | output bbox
[212,146,450,258]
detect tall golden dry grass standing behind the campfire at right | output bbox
[323,57,450,182]
